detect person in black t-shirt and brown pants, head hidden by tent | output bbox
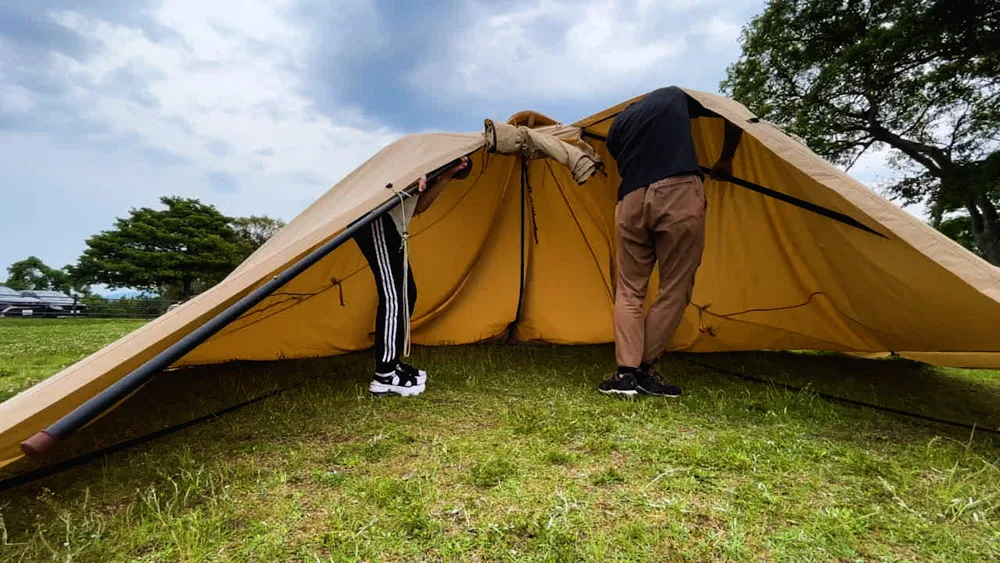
[599,86,742,397]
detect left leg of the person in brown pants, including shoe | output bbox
[600,189,656,395]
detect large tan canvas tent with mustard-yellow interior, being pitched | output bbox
[0,90,1000,464]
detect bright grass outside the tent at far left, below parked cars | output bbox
[0,319,145,401]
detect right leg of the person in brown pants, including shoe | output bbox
[640,176,705,395]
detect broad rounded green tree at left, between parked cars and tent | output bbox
[74,197,243,299]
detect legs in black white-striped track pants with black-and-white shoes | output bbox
[359,215,426,395]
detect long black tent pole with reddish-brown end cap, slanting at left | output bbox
[21,153,472,459]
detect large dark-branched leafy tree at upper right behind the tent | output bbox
[721,0,1000,265]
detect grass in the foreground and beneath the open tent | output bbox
[0,323,1000,561]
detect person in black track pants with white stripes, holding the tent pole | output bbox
[353,156,472,396]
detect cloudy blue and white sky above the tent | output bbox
[0,0,908,277]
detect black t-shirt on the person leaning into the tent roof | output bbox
[607,86,716,200]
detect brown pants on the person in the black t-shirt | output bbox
[615,175,706,367]
